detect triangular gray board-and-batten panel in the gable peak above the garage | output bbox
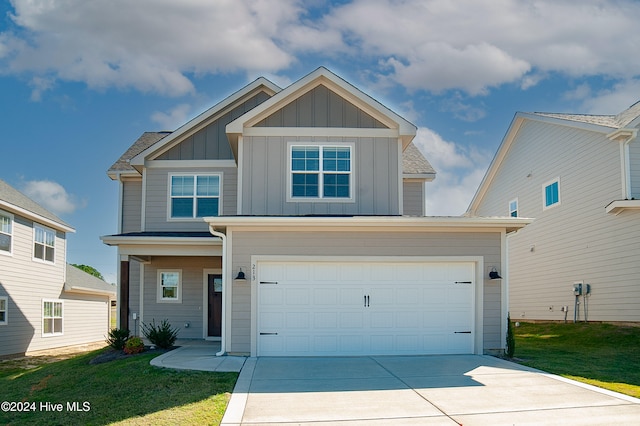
[256,85,387,128]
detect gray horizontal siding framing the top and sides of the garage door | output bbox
[227,230,504,353]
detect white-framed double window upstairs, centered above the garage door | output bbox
[290,145,352,199]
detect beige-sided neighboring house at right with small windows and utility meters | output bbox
[468,103,640,322]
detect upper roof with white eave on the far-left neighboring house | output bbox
[0,179,75,232]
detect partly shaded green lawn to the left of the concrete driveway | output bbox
[0,351,238,425]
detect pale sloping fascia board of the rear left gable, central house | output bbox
[130,77,282,167]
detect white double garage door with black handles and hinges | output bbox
[257,262,475,356]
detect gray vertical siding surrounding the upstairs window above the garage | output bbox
[241,136,400,215]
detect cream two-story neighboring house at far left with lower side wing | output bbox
[0,180,116,356]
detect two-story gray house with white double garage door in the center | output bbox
[102,68,529,356]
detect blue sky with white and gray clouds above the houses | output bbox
[0,0,640,282]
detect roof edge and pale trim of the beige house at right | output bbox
[466,101,640,215]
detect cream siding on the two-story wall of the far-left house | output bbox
[0,214,68,355]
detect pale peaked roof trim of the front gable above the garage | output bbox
[227,67,417,153]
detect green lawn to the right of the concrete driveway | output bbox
[514,322,640,398]
